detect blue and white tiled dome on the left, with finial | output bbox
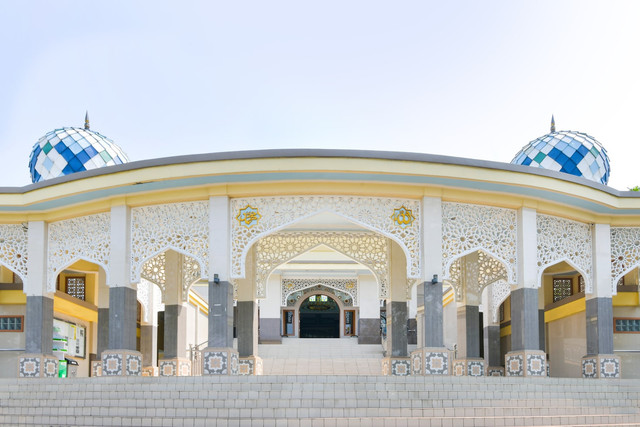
[29,117,129,182]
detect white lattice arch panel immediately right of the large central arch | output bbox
[442,202,518,286]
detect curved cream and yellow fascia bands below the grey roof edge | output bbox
[0,157,640,225]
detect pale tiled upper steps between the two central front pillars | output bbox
[258,338,415,375]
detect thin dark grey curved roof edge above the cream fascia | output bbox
[5,148,640,198]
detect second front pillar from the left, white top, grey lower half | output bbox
[101,205,142,376]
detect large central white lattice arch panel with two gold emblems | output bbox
[230,196,422,284]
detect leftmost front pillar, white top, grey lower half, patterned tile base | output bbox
[18,221,58,378]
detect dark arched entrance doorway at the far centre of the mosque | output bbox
[299,295,340,338]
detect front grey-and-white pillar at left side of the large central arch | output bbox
[202,196,238,375]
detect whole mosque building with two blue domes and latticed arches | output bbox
[0,114,640,378]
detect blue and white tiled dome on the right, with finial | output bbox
[511,119,610,185]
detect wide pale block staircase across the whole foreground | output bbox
[0,375,640,426]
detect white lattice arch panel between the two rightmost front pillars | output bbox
[536,214,593,293]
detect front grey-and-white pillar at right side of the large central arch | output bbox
[411,197,451,375]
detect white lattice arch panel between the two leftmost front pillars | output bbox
[47,213,111,292]
